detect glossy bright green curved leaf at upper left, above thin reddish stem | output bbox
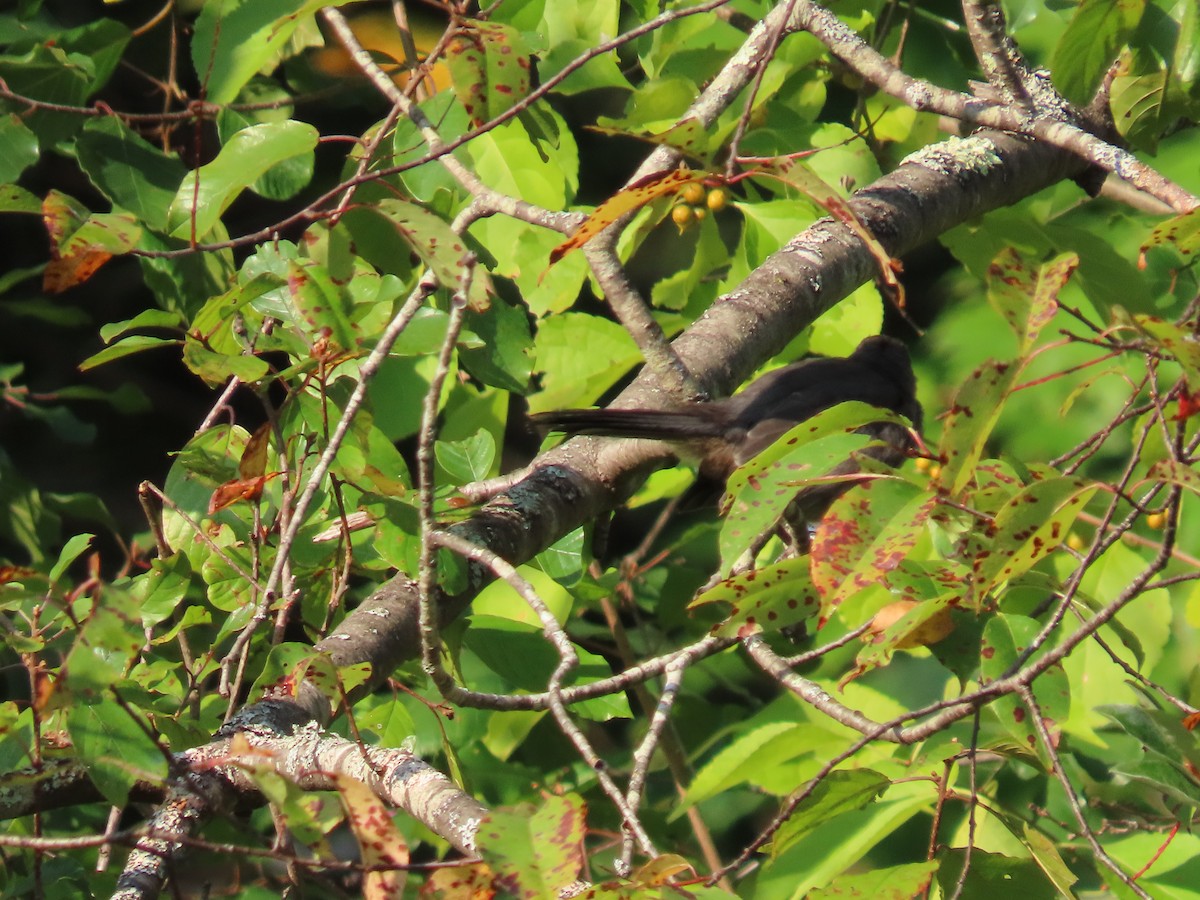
[167,120,318,240]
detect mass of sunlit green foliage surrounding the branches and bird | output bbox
[0,0,1200,898]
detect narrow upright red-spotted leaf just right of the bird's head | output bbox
[937,360,1020,497]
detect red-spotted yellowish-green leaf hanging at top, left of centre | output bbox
[445,19,529,127]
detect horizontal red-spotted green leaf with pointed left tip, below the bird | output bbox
[690,557,821,637]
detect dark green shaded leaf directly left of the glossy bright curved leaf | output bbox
[76,116,186,232]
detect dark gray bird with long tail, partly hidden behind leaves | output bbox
[532,335,922,522]
